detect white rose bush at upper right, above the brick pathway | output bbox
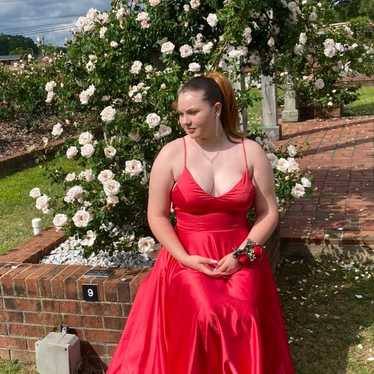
[277,0,374,118]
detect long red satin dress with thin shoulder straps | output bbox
[107,138,294,374]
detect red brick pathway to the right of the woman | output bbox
[277,116,374,256]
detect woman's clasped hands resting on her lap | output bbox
[183,252,242,278]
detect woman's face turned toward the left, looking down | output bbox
[177,91,221,139]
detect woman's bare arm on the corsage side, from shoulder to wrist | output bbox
[240,141,279,247]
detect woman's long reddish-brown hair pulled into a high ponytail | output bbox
[178,72,246,141]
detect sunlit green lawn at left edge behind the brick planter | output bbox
[0,157,74,253]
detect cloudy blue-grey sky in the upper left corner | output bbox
[0,0,110,46]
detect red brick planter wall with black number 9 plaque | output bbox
[0,229,279,373]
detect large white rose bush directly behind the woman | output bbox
[30,0,312,256]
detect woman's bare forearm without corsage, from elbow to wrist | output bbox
[148,216,188,263]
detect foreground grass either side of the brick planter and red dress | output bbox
[0,259,374,374]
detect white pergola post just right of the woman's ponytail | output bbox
[261,75,279,140]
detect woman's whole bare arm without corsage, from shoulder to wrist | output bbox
[147,142,188,263]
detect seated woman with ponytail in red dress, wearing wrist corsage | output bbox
[107,73,294,374]
